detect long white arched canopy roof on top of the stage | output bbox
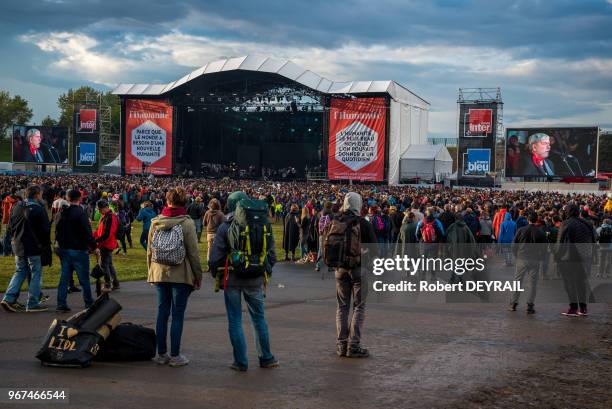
[113,55,429,110]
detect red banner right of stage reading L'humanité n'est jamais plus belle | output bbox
[327,98,387,182]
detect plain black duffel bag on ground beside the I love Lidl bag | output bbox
[95,323,156,361]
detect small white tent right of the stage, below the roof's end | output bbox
[399,145,453,182]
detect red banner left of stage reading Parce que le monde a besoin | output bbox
[125,99,172,175]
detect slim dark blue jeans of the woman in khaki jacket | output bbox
[155,283,193,356]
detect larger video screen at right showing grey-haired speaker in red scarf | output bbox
[506,127,599,177]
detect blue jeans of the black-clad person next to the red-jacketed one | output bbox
[57,249,93,308]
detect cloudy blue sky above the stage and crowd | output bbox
[0,0,612,136]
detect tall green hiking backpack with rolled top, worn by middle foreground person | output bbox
[228,199,272,278]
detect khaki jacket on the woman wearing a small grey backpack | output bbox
[147,215,202,286]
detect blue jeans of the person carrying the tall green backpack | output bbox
[223,287,274,368]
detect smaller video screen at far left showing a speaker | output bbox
[12,125,68,165]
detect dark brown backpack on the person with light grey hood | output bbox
[323,217,361,269]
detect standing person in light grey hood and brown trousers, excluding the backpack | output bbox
[332,192,377,358]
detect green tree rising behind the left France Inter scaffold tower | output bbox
[57,86,121,133]
